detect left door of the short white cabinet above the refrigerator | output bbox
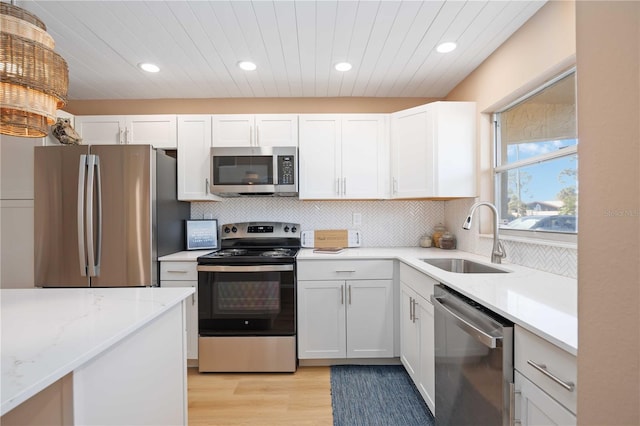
[75,115,126,145]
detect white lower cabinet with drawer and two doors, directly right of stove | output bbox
[297,260,394,359]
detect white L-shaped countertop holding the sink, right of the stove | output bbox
[297,247,578,355]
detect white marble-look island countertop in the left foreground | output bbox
[0,287,194,415]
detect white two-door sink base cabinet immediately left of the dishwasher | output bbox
[400,264,437,413]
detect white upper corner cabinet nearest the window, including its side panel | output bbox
[391,102,477,198]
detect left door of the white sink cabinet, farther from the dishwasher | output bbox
[400,283,420,383]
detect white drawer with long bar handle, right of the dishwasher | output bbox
[514,326,578,413]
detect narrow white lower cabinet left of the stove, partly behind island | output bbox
[160,260,198,360]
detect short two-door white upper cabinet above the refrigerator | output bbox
[75,114,178,149]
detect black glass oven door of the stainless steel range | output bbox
[198,264,296,336]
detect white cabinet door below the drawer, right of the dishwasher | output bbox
[515,371,576,426]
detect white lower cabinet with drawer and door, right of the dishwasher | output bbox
[514,325,577,426]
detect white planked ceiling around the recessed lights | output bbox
[16,0,545,100]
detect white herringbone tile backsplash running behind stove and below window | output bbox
[191,197,578,278]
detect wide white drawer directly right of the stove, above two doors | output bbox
[298,260,393,281]
